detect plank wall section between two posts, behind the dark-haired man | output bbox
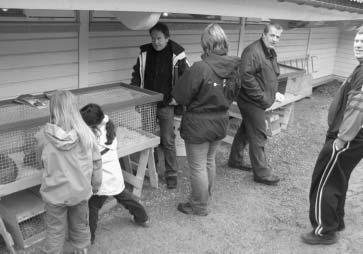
[88,23,239,86]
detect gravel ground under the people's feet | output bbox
[7,83,363,254]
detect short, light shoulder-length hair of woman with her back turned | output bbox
[201,24,228,55]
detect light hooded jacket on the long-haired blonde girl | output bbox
[37,123,97,205]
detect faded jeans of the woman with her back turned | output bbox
[185,140,221,212]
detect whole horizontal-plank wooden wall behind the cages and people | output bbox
[0,20,353,99]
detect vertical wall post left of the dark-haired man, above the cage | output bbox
[77,11,89,88]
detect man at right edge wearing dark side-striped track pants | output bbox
[302,27,363,244]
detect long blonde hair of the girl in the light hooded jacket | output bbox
[49,90,96,148]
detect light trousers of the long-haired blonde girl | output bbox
[43,200,91,254]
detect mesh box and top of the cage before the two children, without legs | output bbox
[0,85,161,189]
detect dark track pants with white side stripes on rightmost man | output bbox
[309,129,363,235]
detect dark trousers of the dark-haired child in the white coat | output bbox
[88,189,149,239]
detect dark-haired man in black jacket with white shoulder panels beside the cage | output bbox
[131,23,189,189]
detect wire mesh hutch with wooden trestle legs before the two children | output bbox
[0,83,162,248]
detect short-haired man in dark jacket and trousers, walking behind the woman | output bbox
[228,24,284,185]
